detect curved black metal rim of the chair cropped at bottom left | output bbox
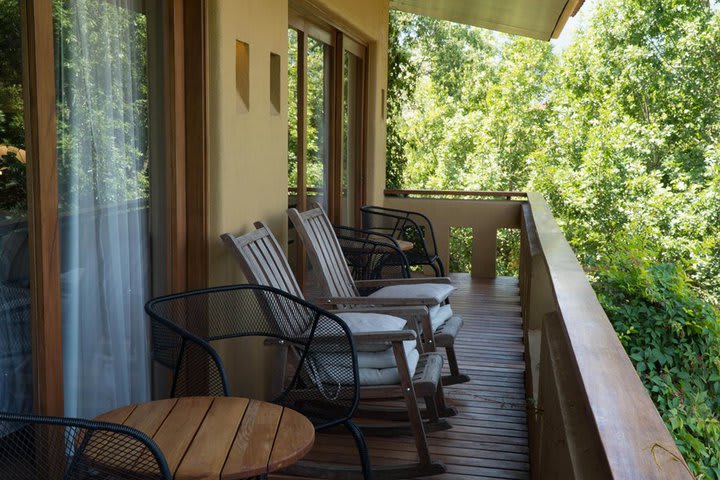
[0,413,172,480]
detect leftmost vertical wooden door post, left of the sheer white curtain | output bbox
[20,0,64,415]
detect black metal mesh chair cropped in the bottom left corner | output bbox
[0,413,172,480]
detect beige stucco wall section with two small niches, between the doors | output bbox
[207,0,287,398]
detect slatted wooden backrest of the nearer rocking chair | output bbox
[220,222,303,298]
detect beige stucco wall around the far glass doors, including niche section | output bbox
[207,0,388,397]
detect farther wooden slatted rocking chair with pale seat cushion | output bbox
[288,204,470,385]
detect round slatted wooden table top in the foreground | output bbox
[96,397,315,480]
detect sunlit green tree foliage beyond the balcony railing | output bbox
[388,0,720,478]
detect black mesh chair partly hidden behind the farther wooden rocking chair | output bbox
[333,225,410,280]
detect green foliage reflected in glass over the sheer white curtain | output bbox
[53,0,150,209]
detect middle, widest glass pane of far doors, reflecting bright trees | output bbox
[305,37,332,211]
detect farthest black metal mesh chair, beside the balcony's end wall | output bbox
[360,205,445,277]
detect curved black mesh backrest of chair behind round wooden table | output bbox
[146,285,359,426]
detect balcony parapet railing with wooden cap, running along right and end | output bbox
[385,191,692,479]
